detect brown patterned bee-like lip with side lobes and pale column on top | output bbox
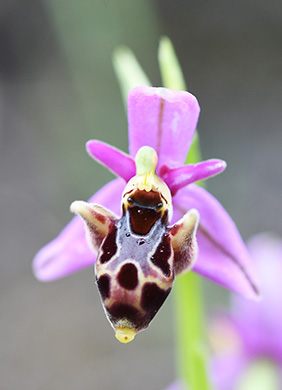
[71,146,199,343]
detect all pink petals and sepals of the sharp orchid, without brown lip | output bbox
[33,86,257,298]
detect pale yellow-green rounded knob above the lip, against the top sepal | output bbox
[135,146,158,175]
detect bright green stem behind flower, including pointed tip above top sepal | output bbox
[158,37,212,390]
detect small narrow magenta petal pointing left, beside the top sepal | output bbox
[86,140,136,181]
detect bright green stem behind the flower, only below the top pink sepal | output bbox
[174,133,212,390]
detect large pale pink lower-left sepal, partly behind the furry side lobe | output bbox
[33,179,125,282]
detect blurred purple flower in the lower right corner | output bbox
[210,233,282,390]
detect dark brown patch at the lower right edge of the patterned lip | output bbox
[141,283,171,312]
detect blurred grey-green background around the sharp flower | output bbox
[0,0,282,390]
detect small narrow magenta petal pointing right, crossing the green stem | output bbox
[160,159,226,195]
